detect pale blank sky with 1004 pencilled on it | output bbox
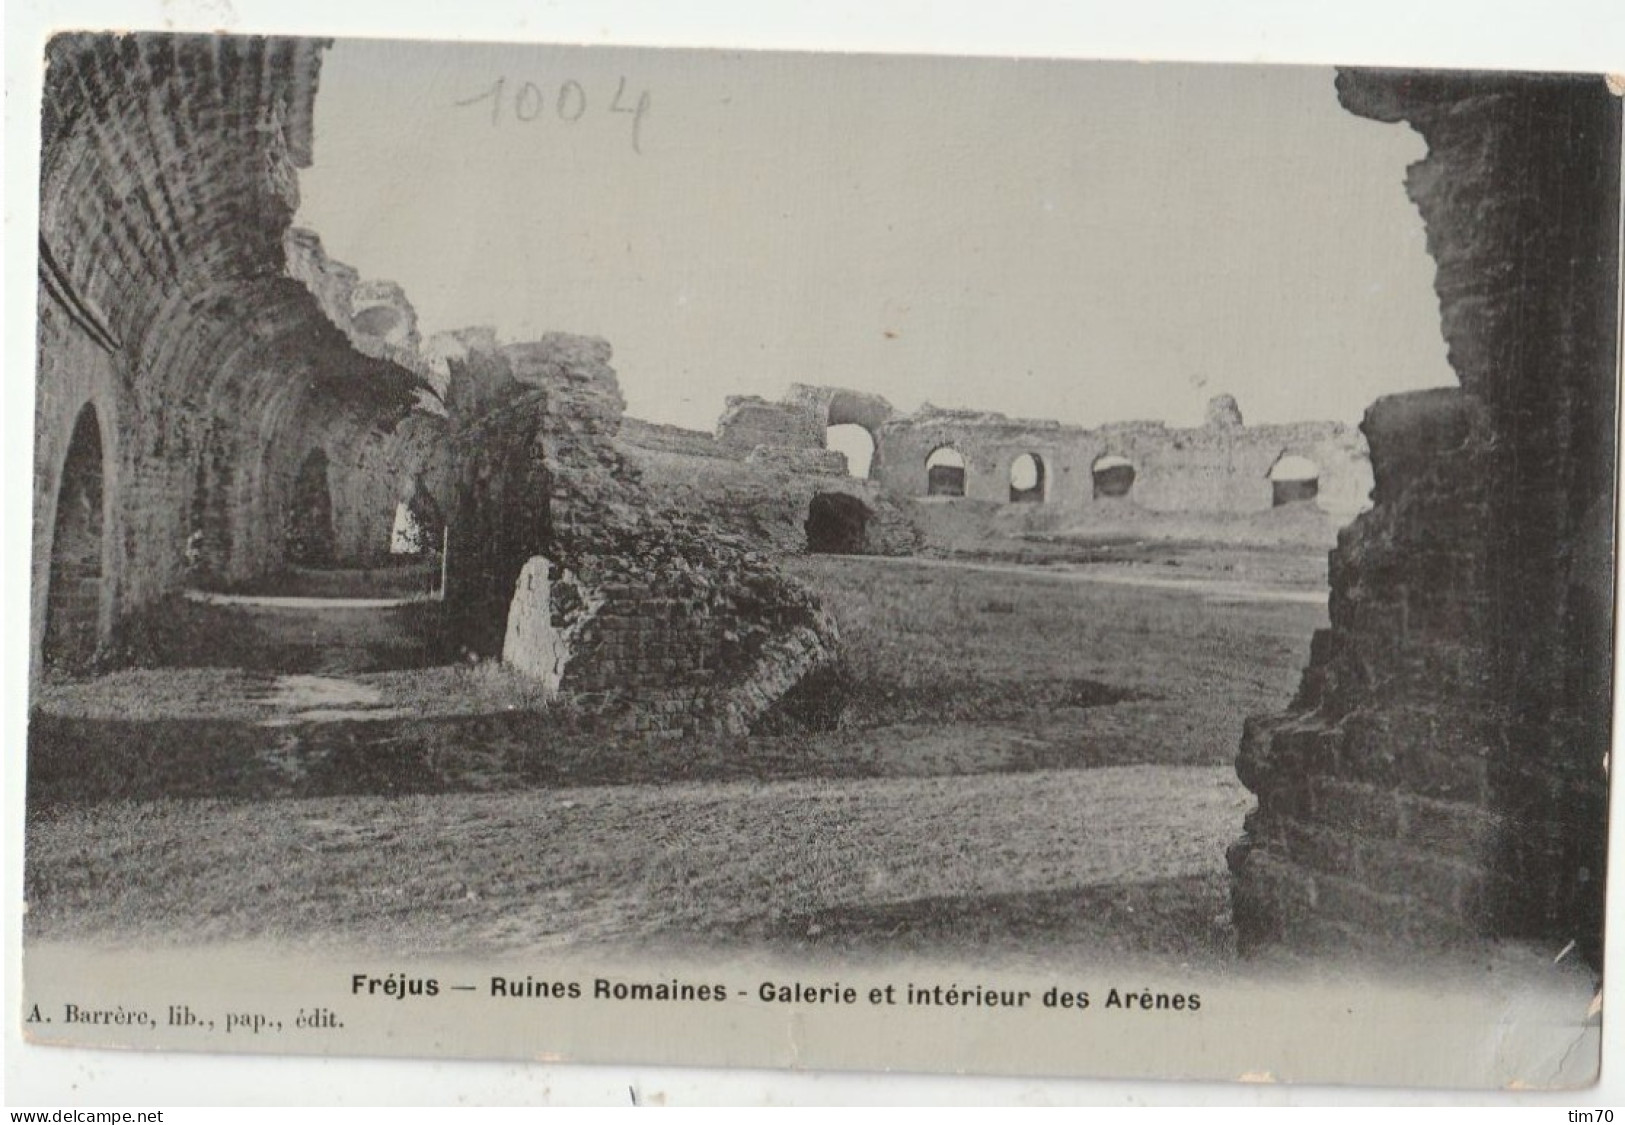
[297,41,1454,429]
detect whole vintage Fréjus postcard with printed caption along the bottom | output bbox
[10,13,1622,1089]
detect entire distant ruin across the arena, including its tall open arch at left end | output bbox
[692,384,1372,554]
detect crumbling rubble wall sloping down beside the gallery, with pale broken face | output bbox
[447,333,835,738]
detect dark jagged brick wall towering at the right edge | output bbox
[1232,72,1620,964]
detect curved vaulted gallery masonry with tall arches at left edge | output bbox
[31,34,442,675]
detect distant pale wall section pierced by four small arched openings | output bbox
[871,399,1372,515]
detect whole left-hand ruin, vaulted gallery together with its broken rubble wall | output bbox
[34,34,834,735]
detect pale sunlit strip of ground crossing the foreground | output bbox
[28,766,1251,953]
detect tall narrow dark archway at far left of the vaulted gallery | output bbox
[41,406,106,671]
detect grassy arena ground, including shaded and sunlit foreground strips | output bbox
[26,558,1324,962]
